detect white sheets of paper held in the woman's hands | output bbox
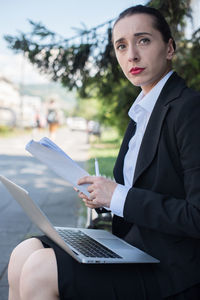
[26,137,89,196]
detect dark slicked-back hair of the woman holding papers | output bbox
[113,5,176,50]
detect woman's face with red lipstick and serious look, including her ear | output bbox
[113,14,174,94]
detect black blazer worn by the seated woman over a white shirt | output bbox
[113,73,200,297]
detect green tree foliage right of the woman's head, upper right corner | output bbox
[149,0,200,91]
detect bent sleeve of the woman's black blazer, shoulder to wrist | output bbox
[124,94,200,239]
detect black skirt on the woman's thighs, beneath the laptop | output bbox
[37,236,161,300]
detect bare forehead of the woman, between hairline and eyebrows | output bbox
[113,14,158,41]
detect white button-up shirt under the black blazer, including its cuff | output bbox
[110,71,173,217]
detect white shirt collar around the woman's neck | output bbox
[128,71,174,120]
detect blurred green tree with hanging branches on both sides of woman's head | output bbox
[5,0,200,132]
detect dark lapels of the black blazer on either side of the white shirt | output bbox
[113,72,186,184]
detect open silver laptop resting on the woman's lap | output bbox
[0,175,159,264]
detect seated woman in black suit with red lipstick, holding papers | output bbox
[8,5,200,300]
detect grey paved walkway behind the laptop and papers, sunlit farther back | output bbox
[0,128,88,300]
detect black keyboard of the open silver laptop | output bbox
[56,228,122,258]
